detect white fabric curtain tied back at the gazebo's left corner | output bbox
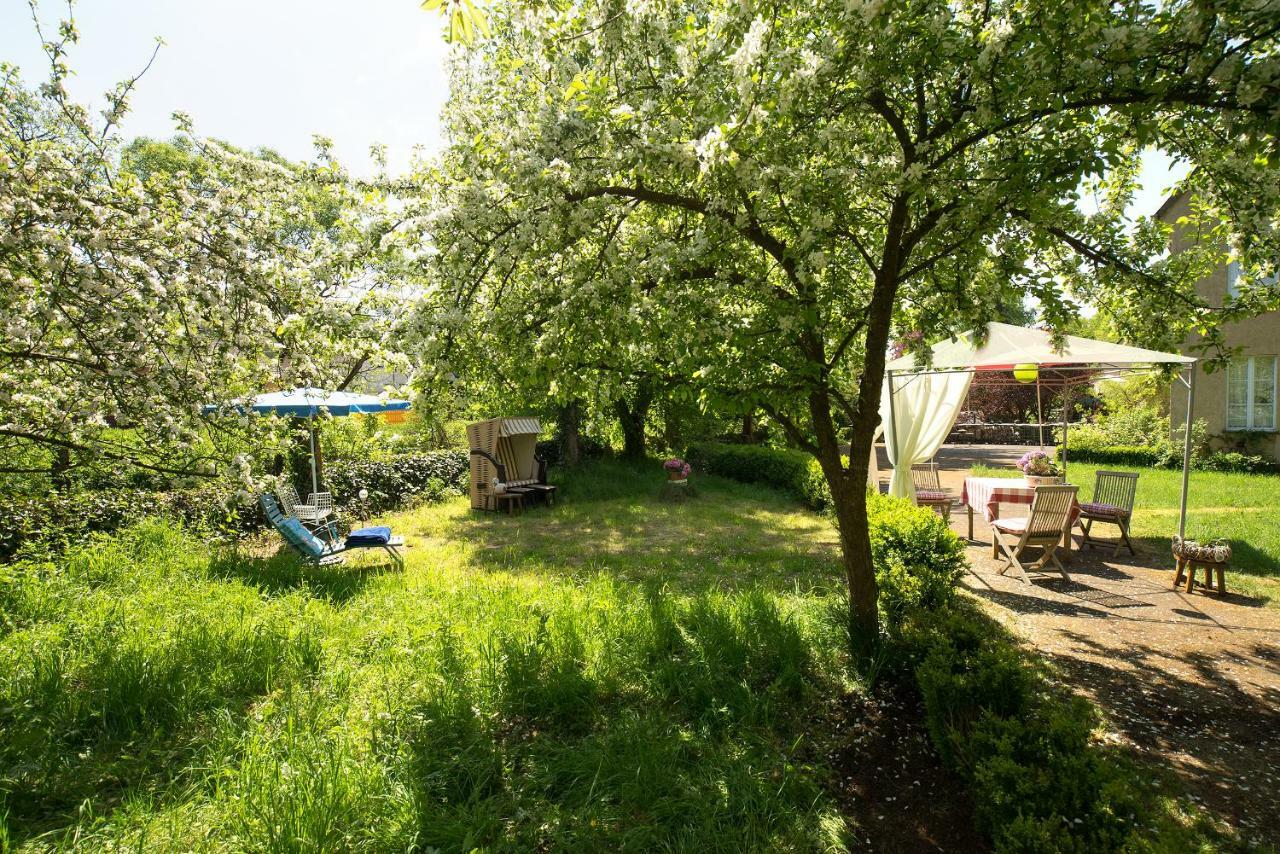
[881,371,973,498]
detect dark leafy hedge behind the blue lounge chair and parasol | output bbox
[0,451,468,560]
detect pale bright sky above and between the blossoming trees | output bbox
[0,0,1187,207]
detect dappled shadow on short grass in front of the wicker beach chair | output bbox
[442,461,844,595]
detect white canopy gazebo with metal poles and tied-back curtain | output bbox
[881,323,1196,536]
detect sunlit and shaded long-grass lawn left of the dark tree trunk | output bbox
[0,465,858,851]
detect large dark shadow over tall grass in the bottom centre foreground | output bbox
[394,592,840,851]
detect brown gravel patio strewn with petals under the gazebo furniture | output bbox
[952,508,1280,844]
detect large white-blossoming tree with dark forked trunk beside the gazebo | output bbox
[417,0,1280,636]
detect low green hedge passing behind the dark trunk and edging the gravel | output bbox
[687,442,1201,853]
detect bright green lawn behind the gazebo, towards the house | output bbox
[974,462,1280,603]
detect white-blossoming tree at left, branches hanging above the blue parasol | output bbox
[0,20,392,483]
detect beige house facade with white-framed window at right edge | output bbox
[1156,193,1280,460]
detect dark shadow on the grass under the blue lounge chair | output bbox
[209,549,396,604]
